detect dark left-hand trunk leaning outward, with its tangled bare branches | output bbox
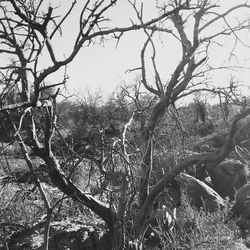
[0,0,186,246]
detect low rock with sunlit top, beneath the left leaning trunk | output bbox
[8,220,112,250]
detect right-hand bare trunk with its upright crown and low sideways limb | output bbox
[128,1,250,246]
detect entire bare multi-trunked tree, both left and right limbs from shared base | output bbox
[0,0,250,249]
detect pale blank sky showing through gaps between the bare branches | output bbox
[17,0,250,100]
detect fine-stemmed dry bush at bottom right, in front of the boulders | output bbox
[152,200,239,250]
